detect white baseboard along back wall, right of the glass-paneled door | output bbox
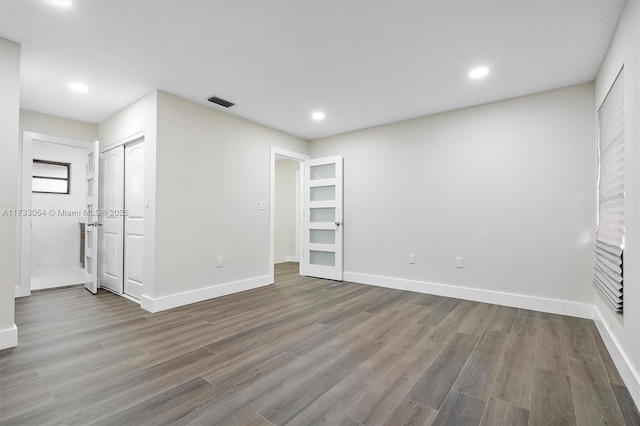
[344,272,593,319]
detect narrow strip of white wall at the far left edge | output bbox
[0,38,20,349]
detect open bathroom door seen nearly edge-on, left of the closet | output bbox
[84,142,100,294]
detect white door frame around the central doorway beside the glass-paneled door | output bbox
[269,146,309,284]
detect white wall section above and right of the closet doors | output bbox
[98,91,157,302]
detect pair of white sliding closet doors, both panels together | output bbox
[99,138,147,302]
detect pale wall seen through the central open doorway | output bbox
[274,160,300,263]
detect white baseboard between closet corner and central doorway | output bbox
[140,275,272,312]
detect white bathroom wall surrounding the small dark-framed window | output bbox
[31,142,87,269]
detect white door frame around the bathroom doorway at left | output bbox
[15,130,99,297]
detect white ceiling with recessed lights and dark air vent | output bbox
[0,0,624,139]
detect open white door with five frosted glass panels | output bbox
[303,156,344,281]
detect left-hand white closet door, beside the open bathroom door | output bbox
[100,146,124,294]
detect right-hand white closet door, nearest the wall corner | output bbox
[124,141,145,299]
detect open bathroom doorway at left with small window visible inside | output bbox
[15,132,94,296]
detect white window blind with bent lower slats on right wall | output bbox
[593,69,625,314]
